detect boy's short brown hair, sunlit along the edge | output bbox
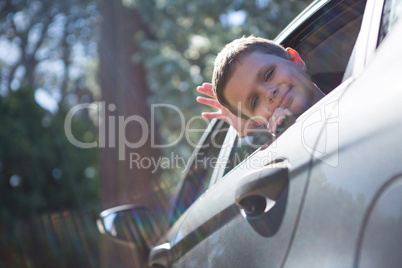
[212,36,288,119]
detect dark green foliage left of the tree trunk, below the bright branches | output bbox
[0,88,98,223]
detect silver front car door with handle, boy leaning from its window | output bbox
[163,1,365,267]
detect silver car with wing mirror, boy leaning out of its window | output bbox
[98,0,402,268]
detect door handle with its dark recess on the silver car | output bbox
[235,161,289,217]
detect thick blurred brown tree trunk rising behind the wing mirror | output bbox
[99,0,163,267]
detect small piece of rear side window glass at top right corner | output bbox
[378,0,402,45]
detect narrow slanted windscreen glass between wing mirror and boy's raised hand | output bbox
[173,121,229,220]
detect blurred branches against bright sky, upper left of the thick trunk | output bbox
[0,0,97,102]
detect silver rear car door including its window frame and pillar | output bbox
[286,0,402,267]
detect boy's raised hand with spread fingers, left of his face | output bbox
[197,83,260,138]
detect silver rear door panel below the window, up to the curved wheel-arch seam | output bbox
[286,12,402,267]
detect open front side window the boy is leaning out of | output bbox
[218,0,366,180]
